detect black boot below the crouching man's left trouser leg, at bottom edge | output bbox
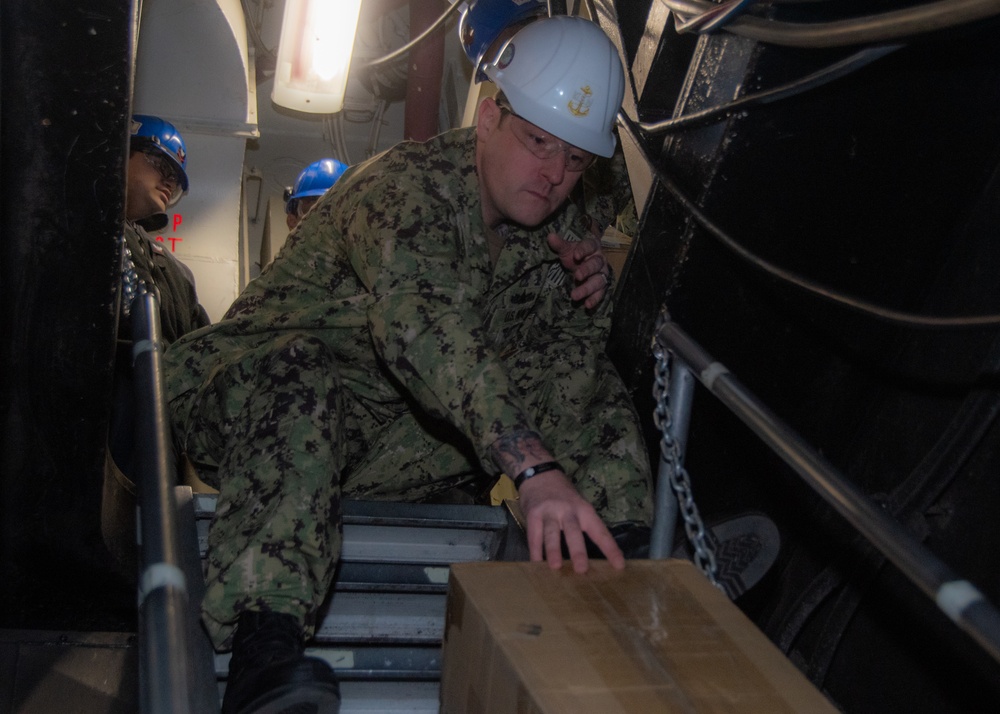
[222,612,340,714]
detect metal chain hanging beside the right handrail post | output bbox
[653,313,722,590]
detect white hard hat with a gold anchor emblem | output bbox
[483,15,625,156]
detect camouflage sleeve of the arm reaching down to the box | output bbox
[348,172,534,472]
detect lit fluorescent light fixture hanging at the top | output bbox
[271,0,361,114]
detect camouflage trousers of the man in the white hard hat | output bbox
[170,335,652,649]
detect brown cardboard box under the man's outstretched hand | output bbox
[441,560,837,714]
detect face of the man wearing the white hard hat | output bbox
[476,99,590,227]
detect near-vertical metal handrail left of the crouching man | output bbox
[131,292,191,714]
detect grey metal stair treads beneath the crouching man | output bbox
[189,494,527,714]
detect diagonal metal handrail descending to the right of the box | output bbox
[655,318,1000,662]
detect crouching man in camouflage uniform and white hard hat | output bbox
[165,17,651,712]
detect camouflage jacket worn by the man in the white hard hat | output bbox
[165,129,611,473]
